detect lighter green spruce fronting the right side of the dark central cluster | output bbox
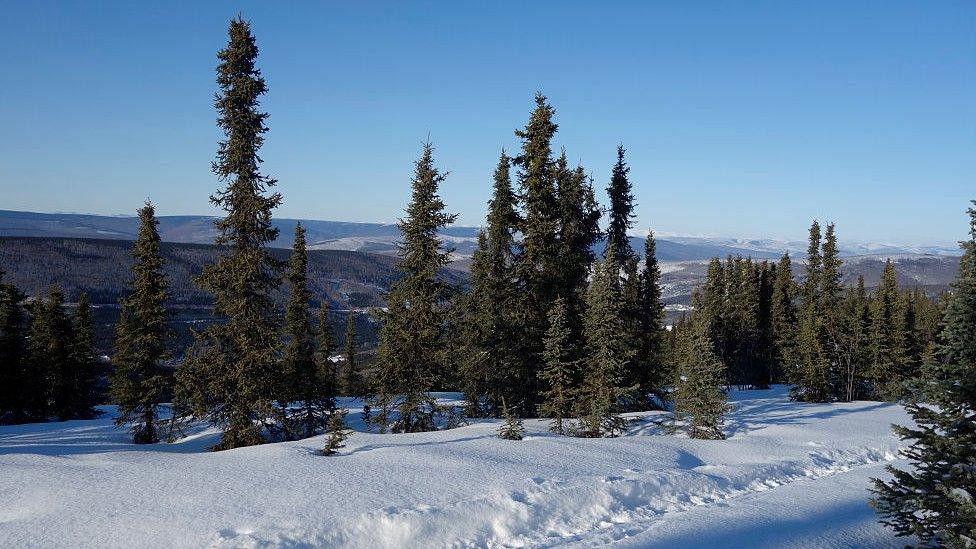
[579,248,636,437]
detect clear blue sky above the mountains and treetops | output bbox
[0,1,976,243]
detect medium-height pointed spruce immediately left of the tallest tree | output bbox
[109,202,169,444]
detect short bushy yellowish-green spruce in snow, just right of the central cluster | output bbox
[674,317,728,439]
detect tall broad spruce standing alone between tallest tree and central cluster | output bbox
[371,143,456,432]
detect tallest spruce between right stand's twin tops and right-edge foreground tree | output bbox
[870,259,906,400]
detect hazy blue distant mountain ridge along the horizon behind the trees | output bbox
[0,210,959,261]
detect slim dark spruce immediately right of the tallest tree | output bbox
[279,223,333,438]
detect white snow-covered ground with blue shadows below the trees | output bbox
[0,387,908,548]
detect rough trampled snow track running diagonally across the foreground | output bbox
[212,443,898,548]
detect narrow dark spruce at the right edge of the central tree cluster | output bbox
[634,231,669,408]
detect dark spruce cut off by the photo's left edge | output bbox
[0,278,27,424]
